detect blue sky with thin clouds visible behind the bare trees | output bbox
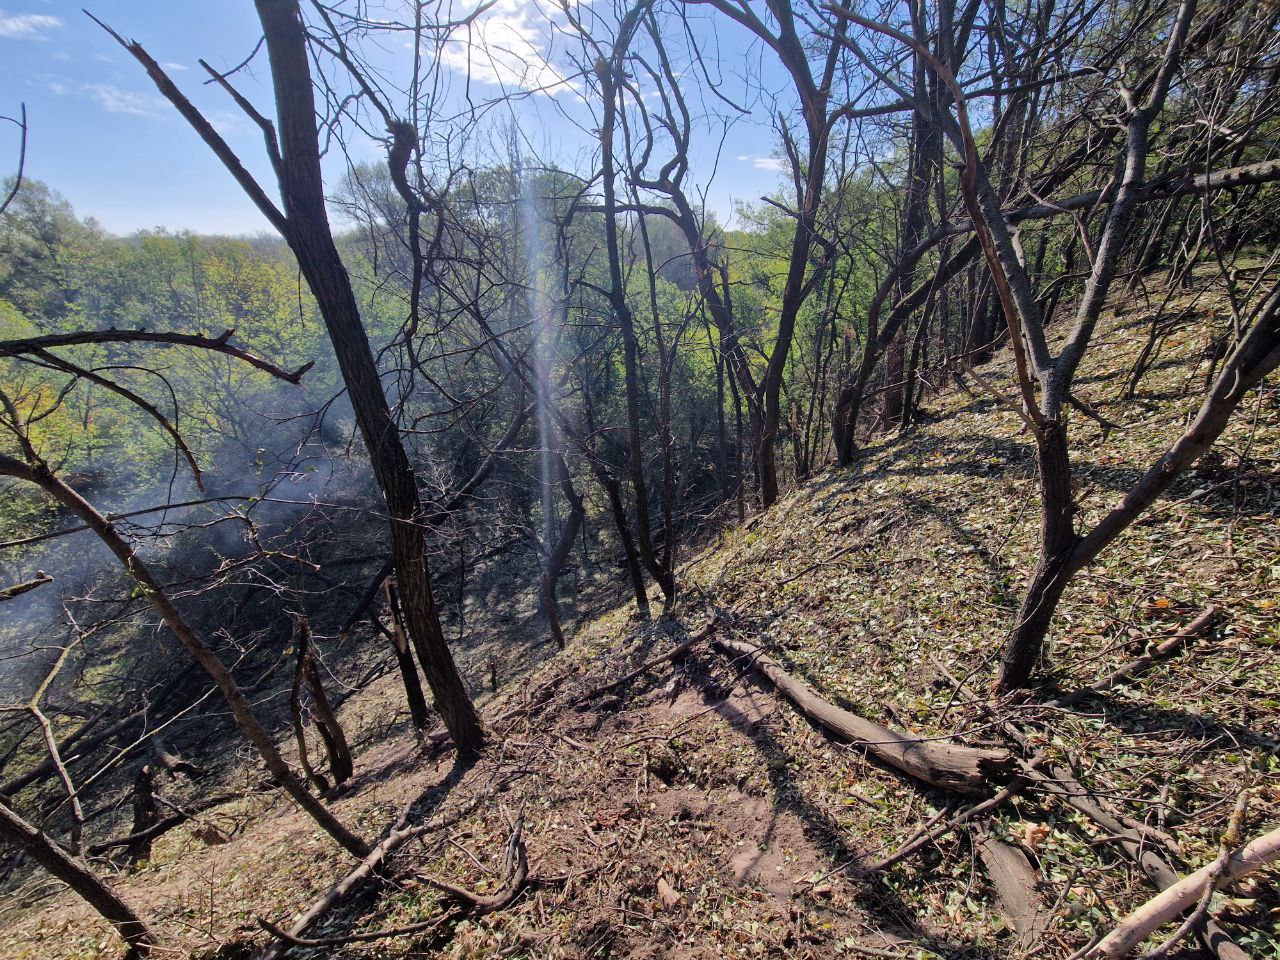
[0,0,793,234]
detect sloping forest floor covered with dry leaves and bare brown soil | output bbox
[0,264,1280,960]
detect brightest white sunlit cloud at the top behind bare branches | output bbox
[440,0,575,93]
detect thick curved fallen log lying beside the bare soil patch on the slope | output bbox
[712,637,1016,796]
